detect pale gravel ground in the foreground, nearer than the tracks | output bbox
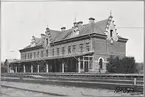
[1,81,143,97]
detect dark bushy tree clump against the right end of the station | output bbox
[107,57,136,73]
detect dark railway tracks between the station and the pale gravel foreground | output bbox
[2,73,144,92]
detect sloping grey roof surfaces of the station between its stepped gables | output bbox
[20,19,127,49]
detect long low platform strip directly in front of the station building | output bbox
[1,72,144,80]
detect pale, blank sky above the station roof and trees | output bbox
[1,1,144,62]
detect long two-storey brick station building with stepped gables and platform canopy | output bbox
[10,15,128,73]
